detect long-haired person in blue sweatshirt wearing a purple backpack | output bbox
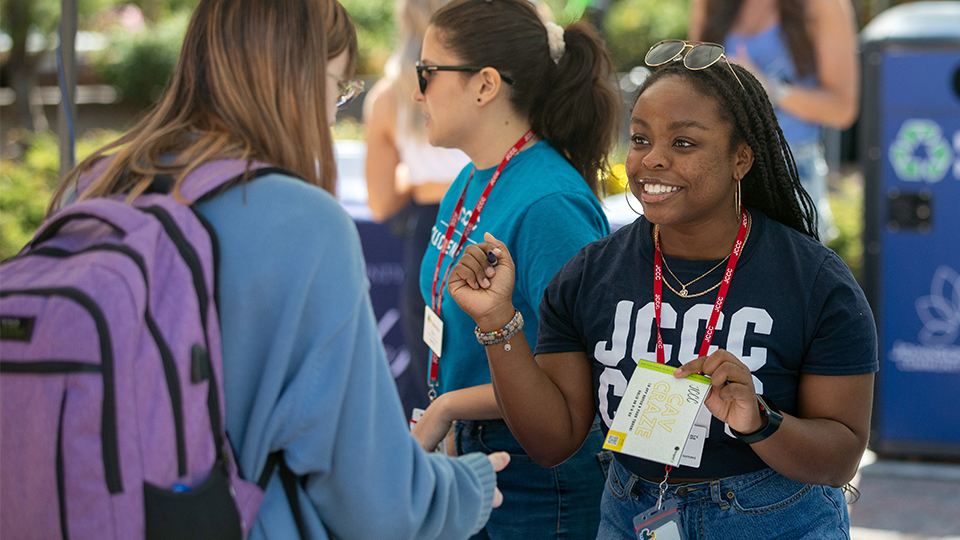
[0,0,509,539]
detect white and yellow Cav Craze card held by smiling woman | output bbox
[603,360,710,467]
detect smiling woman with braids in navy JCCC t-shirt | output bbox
[449,41,878,540]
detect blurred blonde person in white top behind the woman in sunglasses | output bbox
[363,0,470,417]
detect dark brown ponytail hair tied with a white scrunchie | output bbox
[430,0,622,193]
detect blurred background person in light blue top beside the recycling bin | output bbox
[689,0,860,242]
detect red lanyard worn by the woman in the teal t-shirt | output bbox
[430,129,533,396]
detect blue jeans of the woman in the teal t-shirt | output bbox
[456,420,612,540]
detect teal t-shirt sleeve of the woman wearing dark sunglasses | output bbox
[508,192,610,313]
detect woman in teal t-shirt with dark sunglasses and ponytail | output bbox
[414,0,619,539]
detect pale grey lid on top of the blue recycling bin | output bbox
[860,1,960,43]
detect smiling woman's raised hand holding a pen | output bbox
[447,233,516,332]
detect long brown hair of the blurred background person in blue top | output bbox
[700,0,817,76]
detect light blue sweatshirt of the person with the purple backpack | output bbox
[198,175,495,539]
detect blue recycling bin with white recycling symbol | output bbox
[860,2,960,457]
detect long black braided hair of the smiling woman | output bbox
[637,60,819,240]
